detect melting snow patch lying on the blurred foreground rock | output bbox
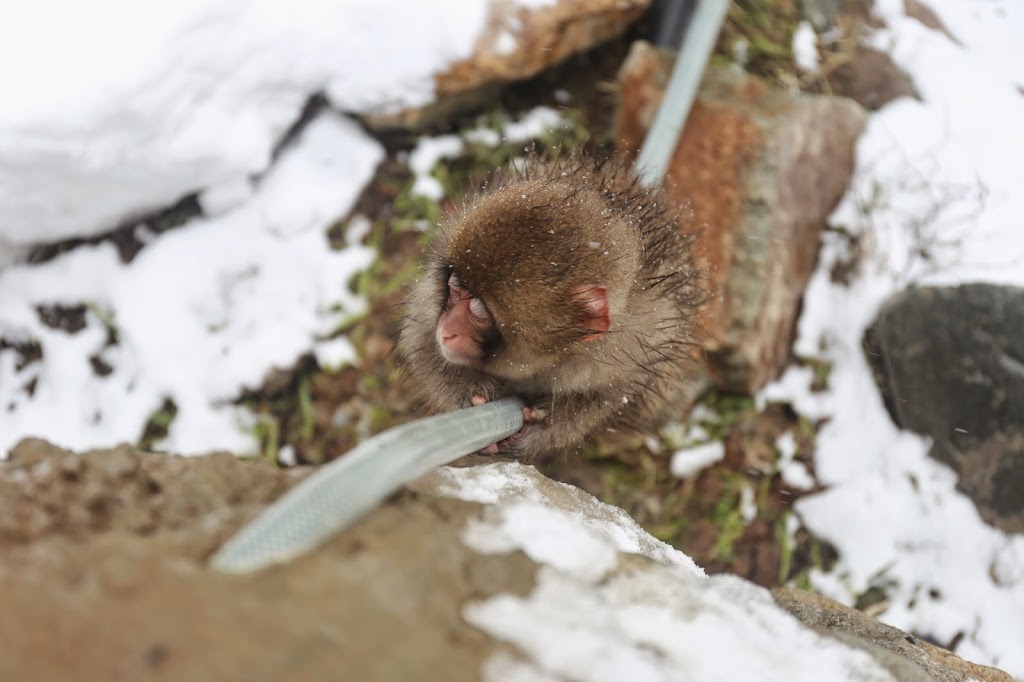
[429,463,892,682]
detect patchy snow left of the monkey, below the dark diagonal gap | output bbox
[0,113,383,454]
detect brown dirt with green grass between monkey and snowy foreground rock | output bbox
[539,396,836,587]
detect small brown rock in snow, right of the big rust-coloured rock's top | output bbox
[828,45,921,112]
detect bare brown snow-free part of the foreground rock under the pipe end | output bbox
[0,440,534,682]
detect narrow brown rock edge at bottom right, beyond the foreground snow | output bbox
[772,588,1013,682]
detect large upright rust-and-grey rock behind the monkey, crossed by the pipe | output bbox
[614,43,865,392]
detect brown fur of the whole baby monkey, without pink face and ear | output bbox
[399,155,700,461]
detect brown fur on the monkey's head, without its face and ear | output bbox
[434,158,640,376]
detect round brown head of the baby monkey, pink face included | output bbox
[428,176,636,382]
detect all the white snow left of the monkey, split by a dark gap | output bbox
[0,0,488,453]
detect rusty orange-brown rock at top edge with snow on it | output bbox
[364,0,650,130]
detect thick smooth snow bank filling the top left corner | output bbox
[0,0,489,252]
